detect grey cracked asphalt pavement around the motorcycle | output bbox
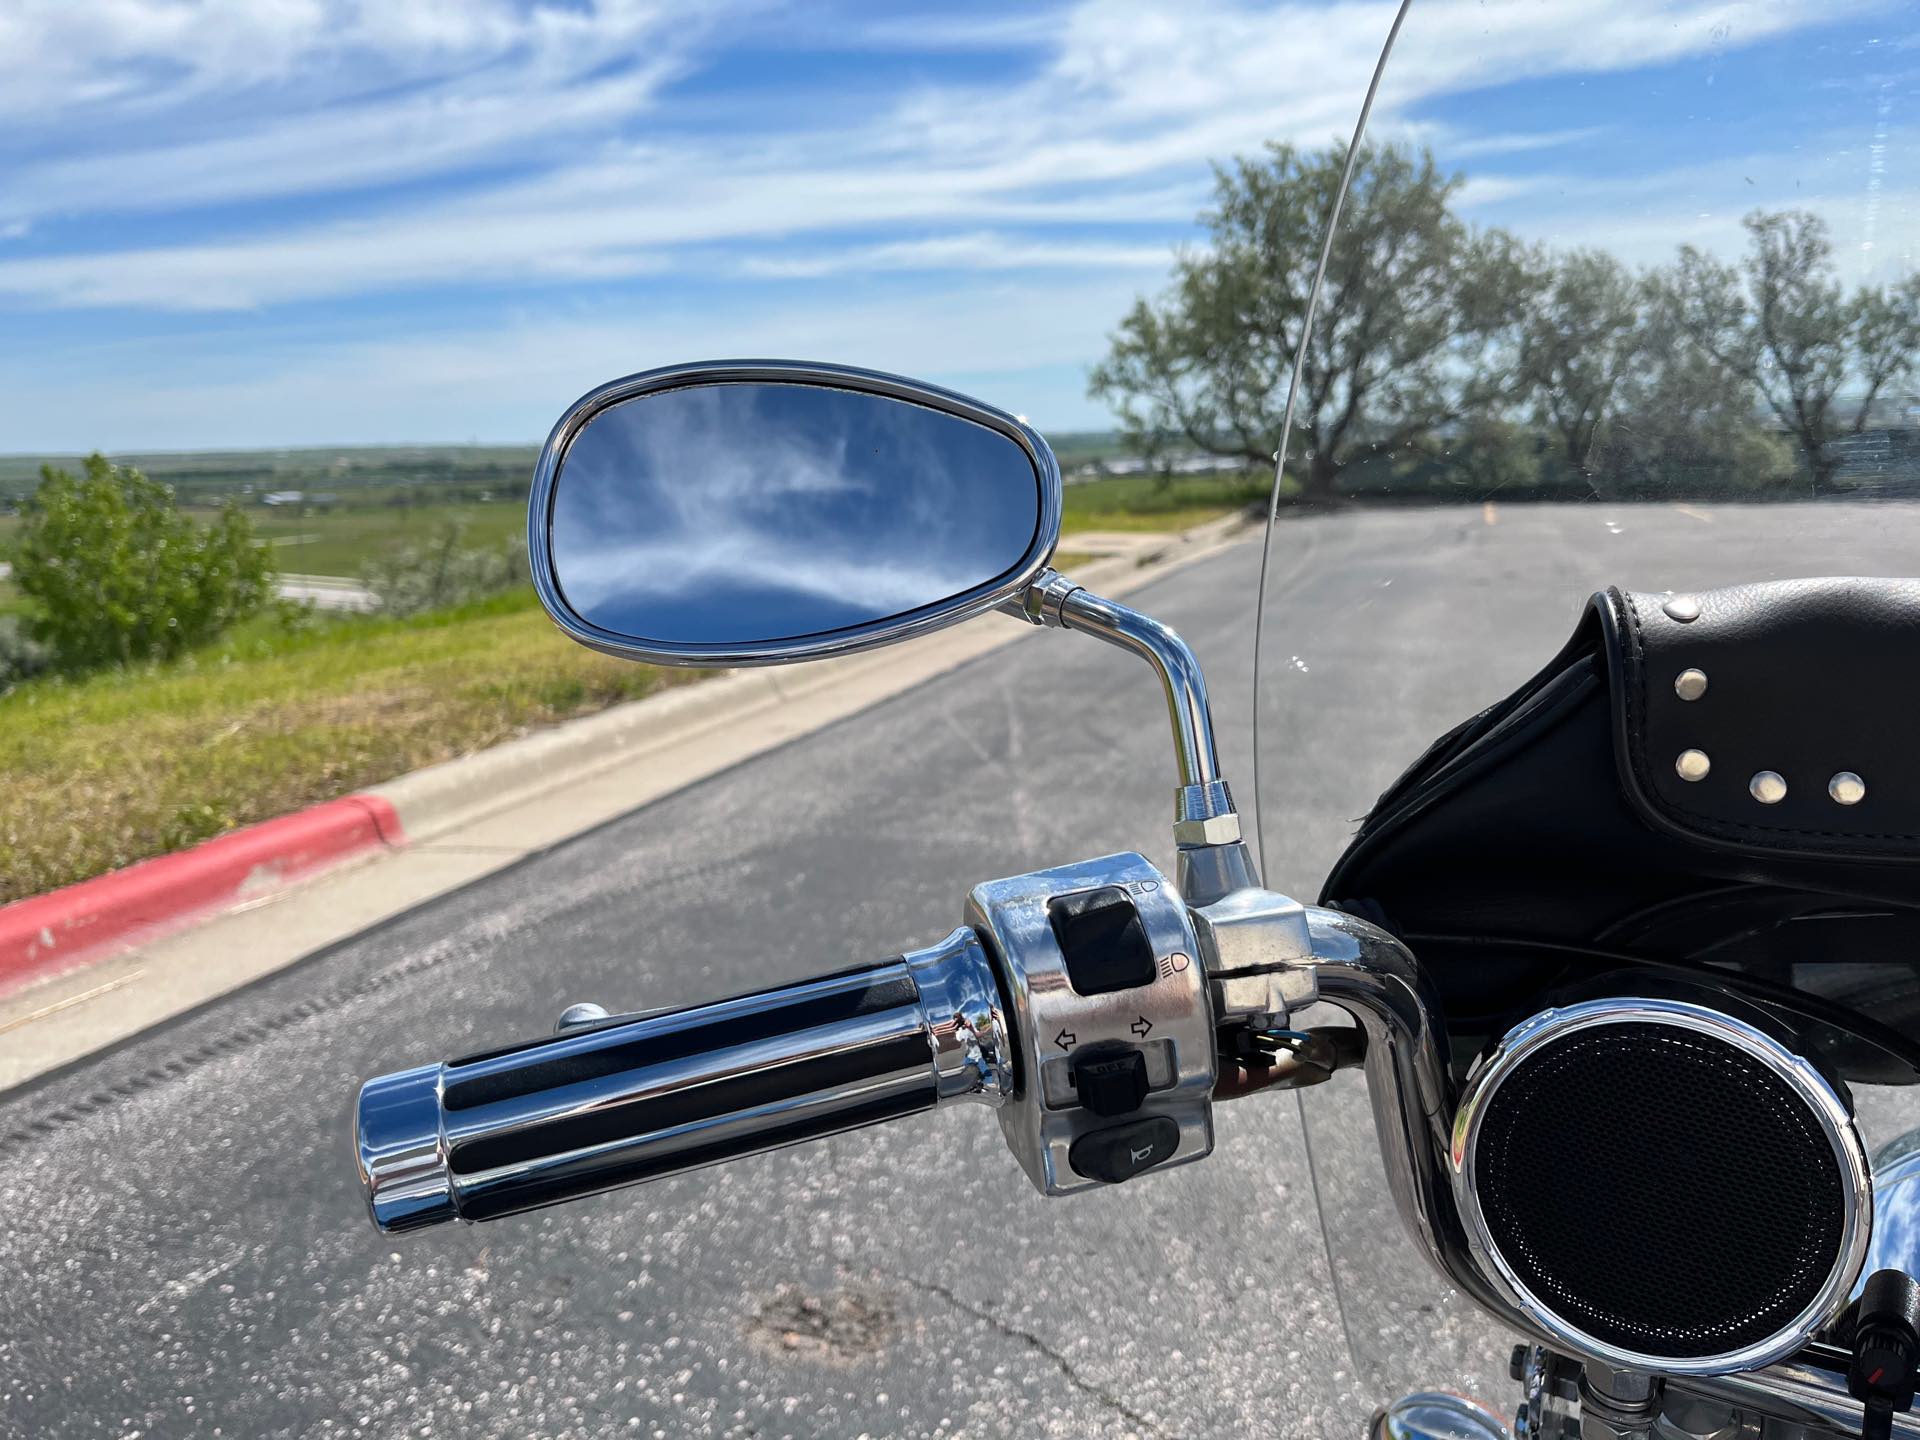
[0,505,1920,1436]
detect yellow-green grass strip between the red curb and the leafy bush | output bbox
[0,591,699,904]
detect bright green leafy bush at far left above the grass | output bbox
[13,455,275,670]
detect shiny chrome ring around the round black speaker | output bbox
[1448,998,1874,1375]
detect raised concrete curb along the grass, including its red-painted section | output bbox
[0,515,1248,998]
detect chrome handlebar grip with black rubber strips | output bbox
[355,929,1014,1233]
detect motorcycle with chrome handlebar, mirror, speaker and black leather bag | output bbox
[355,361,1920,1440]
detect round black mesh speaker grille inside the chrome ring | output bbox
[1475,1021,1845,1359]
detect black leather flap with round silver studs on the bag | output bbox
[1594,580,1920,862]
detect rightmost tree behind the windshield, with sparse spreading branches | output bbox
[1676,209,1920,493]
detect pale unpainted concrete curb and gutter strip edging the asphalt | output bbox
[0,516,1258,1089]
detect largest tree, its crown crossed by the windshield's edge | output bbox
[1089,144,1526,499]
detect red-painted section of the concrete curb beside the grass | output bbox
[0,795,405,995]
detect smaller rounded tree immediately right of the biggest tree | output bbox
[1517,250,1645,476]
